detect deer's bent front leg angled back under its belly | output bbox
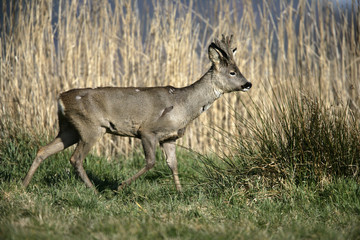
[118,133,157,191]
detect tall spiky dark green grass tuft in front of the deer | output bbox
[200,96,360,191]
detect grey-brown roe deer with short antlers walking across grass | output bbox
[23,35,252,192]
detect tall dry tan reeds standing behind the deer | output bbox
[0,0,360,156]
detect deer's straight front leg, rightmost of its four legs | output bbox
[161,141,182,192]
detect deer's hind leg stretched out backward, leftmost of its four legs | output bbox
[23,128,79,187]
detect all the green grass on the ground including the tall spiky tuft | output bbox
[0,94,360,239]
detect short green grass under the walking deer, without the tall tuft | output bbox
[0,111,360,239]
